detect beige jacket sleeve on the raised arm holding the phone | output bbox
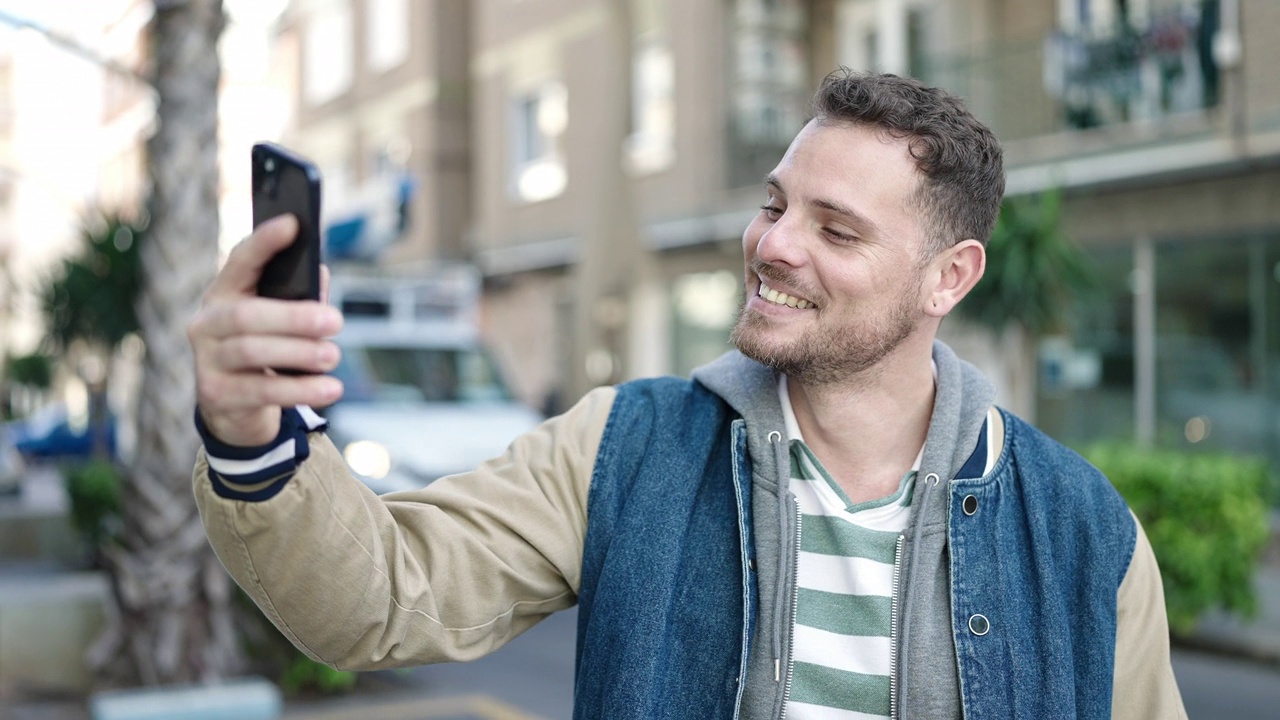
[195,388,614,670]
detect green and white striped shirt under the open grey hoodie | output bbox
[778,377,996,720]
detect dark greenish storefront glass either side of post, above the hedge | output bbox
[1037,237,1280,462]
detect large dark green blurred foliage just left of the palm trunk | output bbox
[40,214,145,352]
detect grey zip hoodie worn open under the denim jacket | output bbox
[694,341,995,720]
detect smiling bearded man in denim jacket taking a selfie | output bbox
[191,72,1184,719]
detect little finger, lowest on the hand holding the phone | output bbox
[200,372,343,415]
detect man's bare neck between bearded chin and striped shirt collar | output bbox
[787,338,934,502]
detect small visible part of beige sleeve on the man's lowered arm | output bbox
[1111,507,1187,720]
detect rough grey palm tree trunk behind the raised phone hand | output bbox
[90,0,241,684]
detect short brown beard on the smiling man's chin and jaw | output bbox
[730,266,916,386]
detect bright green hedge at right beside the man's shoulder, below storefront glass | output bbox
[1082,442,1274,634]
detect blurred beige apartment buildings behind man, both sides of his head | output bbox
[277,0,1280,466]
